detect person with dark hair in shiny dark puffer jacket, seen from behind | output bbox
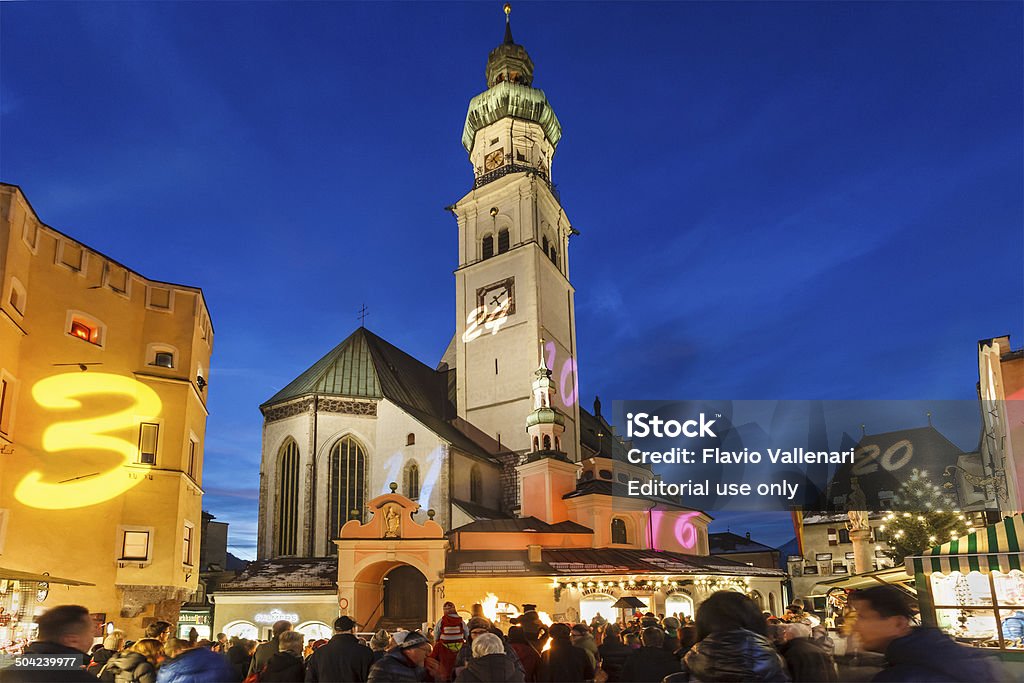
[667,591,790,683]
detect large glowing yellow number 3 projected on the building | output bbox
[14,373,162,510]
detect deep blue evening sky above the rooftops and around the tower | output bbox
[0,2,1024,557]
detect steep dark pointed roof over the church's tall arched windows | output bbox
[261,328,447,417]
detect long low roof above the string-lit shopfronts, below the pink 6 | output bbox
[444,548,785,577]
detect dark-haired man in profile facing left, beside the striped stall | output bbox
[850,586,1004,683]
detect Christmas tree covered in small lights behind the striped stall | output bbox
[879,469,974,564]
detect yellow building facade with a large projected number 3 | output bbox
[0,184,213,643]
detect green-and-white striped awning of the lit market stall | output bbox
[906,515,1024,574]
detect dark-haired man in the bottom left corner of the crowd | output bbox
[0,605,96,683]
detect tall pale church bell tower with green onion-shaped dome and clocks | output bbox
[451,4,580,461]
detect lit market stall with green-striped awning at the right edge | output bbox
[906,515,1024,660]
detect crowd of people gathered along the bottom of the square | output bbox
[0,586,1005,683]
